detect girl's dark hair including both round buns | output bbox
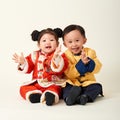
[31,28,63,42]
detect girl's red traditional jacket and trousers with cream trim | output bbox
[18,51,68,103]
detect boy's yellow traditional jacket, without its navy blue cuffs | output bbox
[65,48,102,87]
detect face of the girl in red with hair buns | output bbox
[38,33,58,54]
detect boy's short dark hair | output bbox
[62,24,86,40]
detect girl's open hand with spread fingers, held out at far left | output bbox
[12,53,25,65]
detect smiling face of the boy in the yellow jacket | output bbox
[64,30,86,54]
